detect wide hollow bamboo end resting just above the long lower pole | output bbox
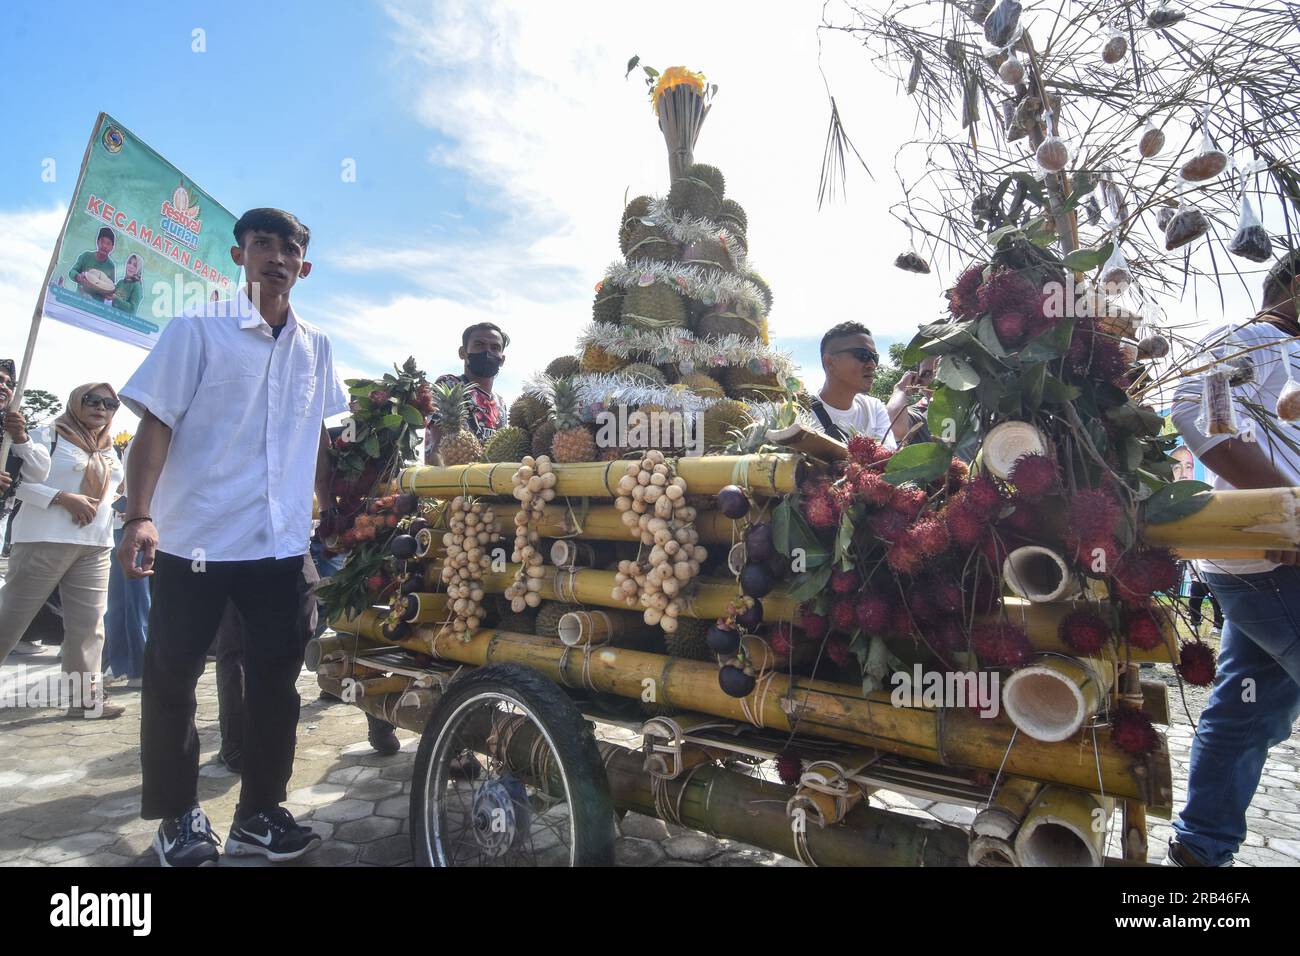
[1002,656,1115,743]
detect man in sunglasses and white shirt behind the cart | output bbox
[813,321,897,449]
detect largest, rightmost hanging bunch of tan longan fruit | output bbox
[612,451,709,633]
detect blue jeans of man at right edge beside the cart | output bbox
[1174,567,1300,866]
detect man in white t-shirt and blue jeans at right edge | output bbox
[1169,251,1300,866]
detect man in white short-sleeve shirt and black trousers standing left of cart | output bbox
[118,209,347,866]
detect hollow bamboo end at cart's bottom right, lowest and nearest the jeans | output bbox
[1015,787,1114,866]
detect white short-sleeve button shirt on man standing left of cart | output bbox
[120,289,347,561]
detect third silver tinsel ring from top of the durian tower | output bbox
[577,323,794,381]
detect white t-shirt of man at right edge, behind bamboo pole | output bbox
[1170,321,1300,575]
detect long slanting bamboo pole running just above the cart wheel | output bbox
[330,613,1173,806]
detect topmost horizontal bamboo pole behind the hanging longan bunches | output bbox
[393,455,802,498]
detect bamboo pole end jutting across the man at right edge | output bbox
[1141,488,1300,550]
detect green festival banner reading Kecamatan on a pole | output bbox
[43,113,239,349]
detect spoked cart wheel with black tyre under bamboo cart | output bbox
[411,665,614,866]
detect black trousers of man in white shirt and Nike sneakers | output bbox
[140,551,306,819]
